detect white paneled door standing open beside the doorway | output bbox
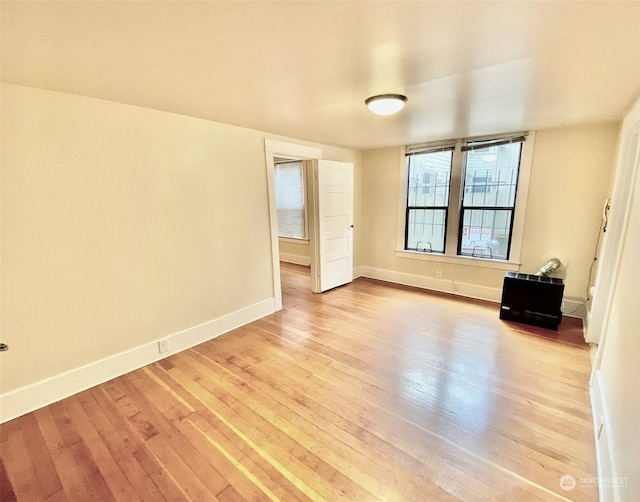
[312,160,353,293]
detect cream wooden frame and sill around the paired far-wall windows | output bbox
[395,131,535,271]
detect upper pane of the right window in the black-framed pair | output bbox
[462,143,522,207]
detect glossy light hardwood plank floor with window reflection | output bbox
[0,264,597,502]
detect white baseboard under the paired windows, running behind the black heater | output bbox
[353,266,586,319]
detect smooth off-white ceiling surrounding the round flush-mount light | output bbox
[1,1,640,148]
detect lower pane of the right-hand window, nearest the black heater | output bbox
[460,209,513,260]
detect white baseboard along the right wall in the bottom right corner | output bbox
[589,370,620,502]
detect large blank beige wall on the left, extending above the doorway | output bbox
[0,84,359,393]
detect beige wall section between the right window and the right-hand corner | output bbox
[521,122,620,299]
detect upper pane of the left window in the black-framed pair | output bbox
[407,151,453,207]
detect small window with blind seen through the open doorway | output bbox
[275,160,307,239]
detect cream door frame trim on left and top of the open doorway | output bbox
[264,138,322,311]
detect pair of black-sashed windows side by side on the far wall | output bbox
[403,135,532,261]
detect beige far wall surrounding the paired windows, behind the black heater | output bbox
[361,123,619,299]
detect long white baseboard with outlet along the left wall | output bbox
[0,298,275,423]
